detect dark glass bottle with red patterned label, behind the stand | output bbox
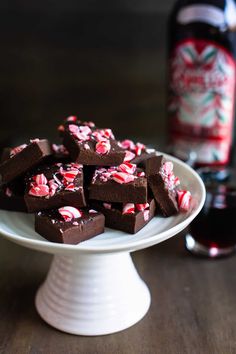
[168,0,236,166]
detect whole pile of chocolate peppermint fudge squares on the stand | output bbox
[0,116,191,244]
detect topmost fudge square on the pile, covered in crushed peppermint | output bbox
[60,116,125,166]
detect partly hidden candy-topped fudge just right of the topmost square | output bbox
[119,139,156,167]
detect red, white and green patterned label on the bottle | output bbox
[168,39,235,164]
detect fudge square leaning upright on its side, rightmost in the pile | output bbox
[146,155,179,216]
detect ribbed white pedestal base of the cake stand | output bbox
[36,252,150,335]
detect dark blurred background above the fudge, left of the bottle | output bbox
[0,0,174,145]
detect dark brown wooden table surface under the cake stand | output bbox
[0,230,236,354]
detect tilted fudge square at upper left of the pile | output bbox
[0,139,52,185]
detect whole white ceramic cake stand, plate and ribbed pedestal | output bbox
[0,155,205,335]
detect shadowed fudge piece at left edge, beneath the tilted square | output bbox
[0,178,27,212]
